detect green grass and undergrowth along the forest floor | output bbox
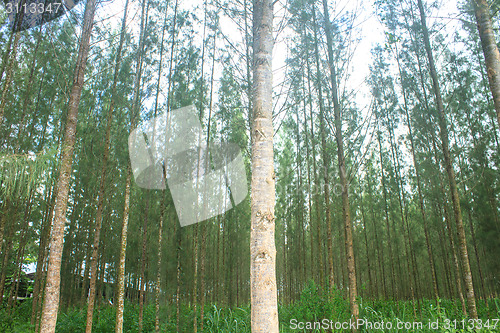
[0,282,500,333]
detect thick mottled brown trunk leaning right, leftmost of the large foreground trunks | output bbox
[40,0,96,333]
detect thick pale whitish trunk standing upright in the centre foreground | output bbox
[250,0,279,333]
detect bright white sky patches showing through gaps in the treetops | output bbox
[81,0,459,122]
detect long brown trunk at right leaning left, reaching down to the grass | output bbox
[418,0,478,319]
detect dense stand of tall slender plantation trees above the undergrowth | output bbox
[0,0,500,332]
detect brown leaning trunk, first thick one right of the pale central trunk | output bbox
[323,0,359,321]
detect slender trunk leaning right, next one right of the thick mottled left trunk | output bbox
[85,0,128,333]
